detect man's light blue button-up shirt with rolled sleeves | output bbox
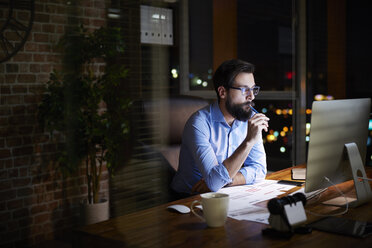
[171,102,266,194]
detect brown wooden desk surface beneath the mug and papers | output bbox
[75,168,372,248]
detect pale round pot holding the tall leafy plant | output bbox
[80,199,110,225]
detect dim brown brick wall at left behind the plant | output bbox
[0,0,109,247]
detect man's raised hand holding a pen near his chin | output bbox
[246,113,269,143]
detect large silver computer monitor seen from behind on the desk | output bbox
[305,98,372,205]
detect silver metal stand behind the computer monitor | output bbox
[322,143,372,207]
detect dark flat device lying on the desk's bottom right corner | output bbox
[310,217,372,238]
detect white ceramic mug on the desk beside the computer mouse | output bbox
[190,192,229,227]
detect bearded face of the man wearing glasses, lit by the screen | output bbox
[225,72,255,121]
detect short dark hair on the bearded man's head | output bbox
[213,59,254,100]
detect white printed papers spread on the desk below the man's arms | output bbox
[218,180,294,224]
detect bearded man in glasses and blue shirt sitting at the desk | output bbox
[171,60,269,196]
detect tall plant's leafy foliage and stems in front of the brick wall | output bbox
[39,27,131,222]
